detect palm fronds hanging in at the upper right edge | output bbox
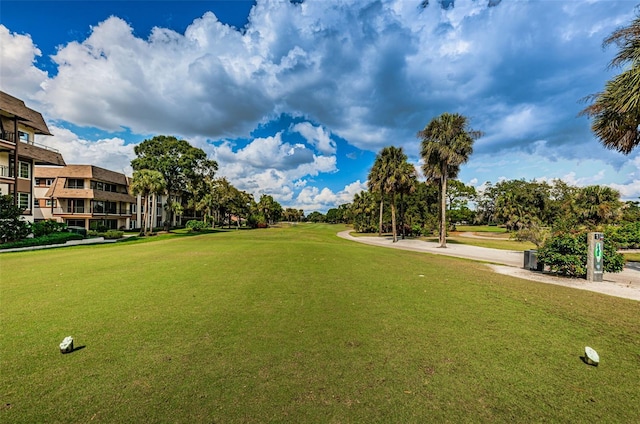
[580,17,640,154]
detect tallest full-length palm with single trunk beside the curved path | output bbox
[418,113,482,247]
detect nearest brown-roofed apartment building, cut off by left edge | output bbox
[0,91,65,222]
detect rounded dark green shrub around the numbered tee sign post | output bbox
[538,232,624,277]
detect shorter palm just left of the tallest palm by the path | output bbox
[369,146,416,243]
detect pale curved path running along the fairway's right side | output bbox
[338,230,640,301]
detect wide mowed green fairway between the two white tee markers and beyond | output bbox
[0,225,640,423]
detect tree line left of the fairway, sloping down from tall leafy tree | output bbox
[130,135,292,234]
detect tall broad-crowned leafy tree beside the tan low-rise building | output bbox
[131,135,218,229]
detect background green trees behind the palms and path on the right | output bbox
[345,173,640,238]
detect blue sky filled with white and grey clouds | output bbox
[0,0,640,213]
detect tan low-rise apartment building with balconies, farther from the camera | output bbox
[34,165,137,230]
